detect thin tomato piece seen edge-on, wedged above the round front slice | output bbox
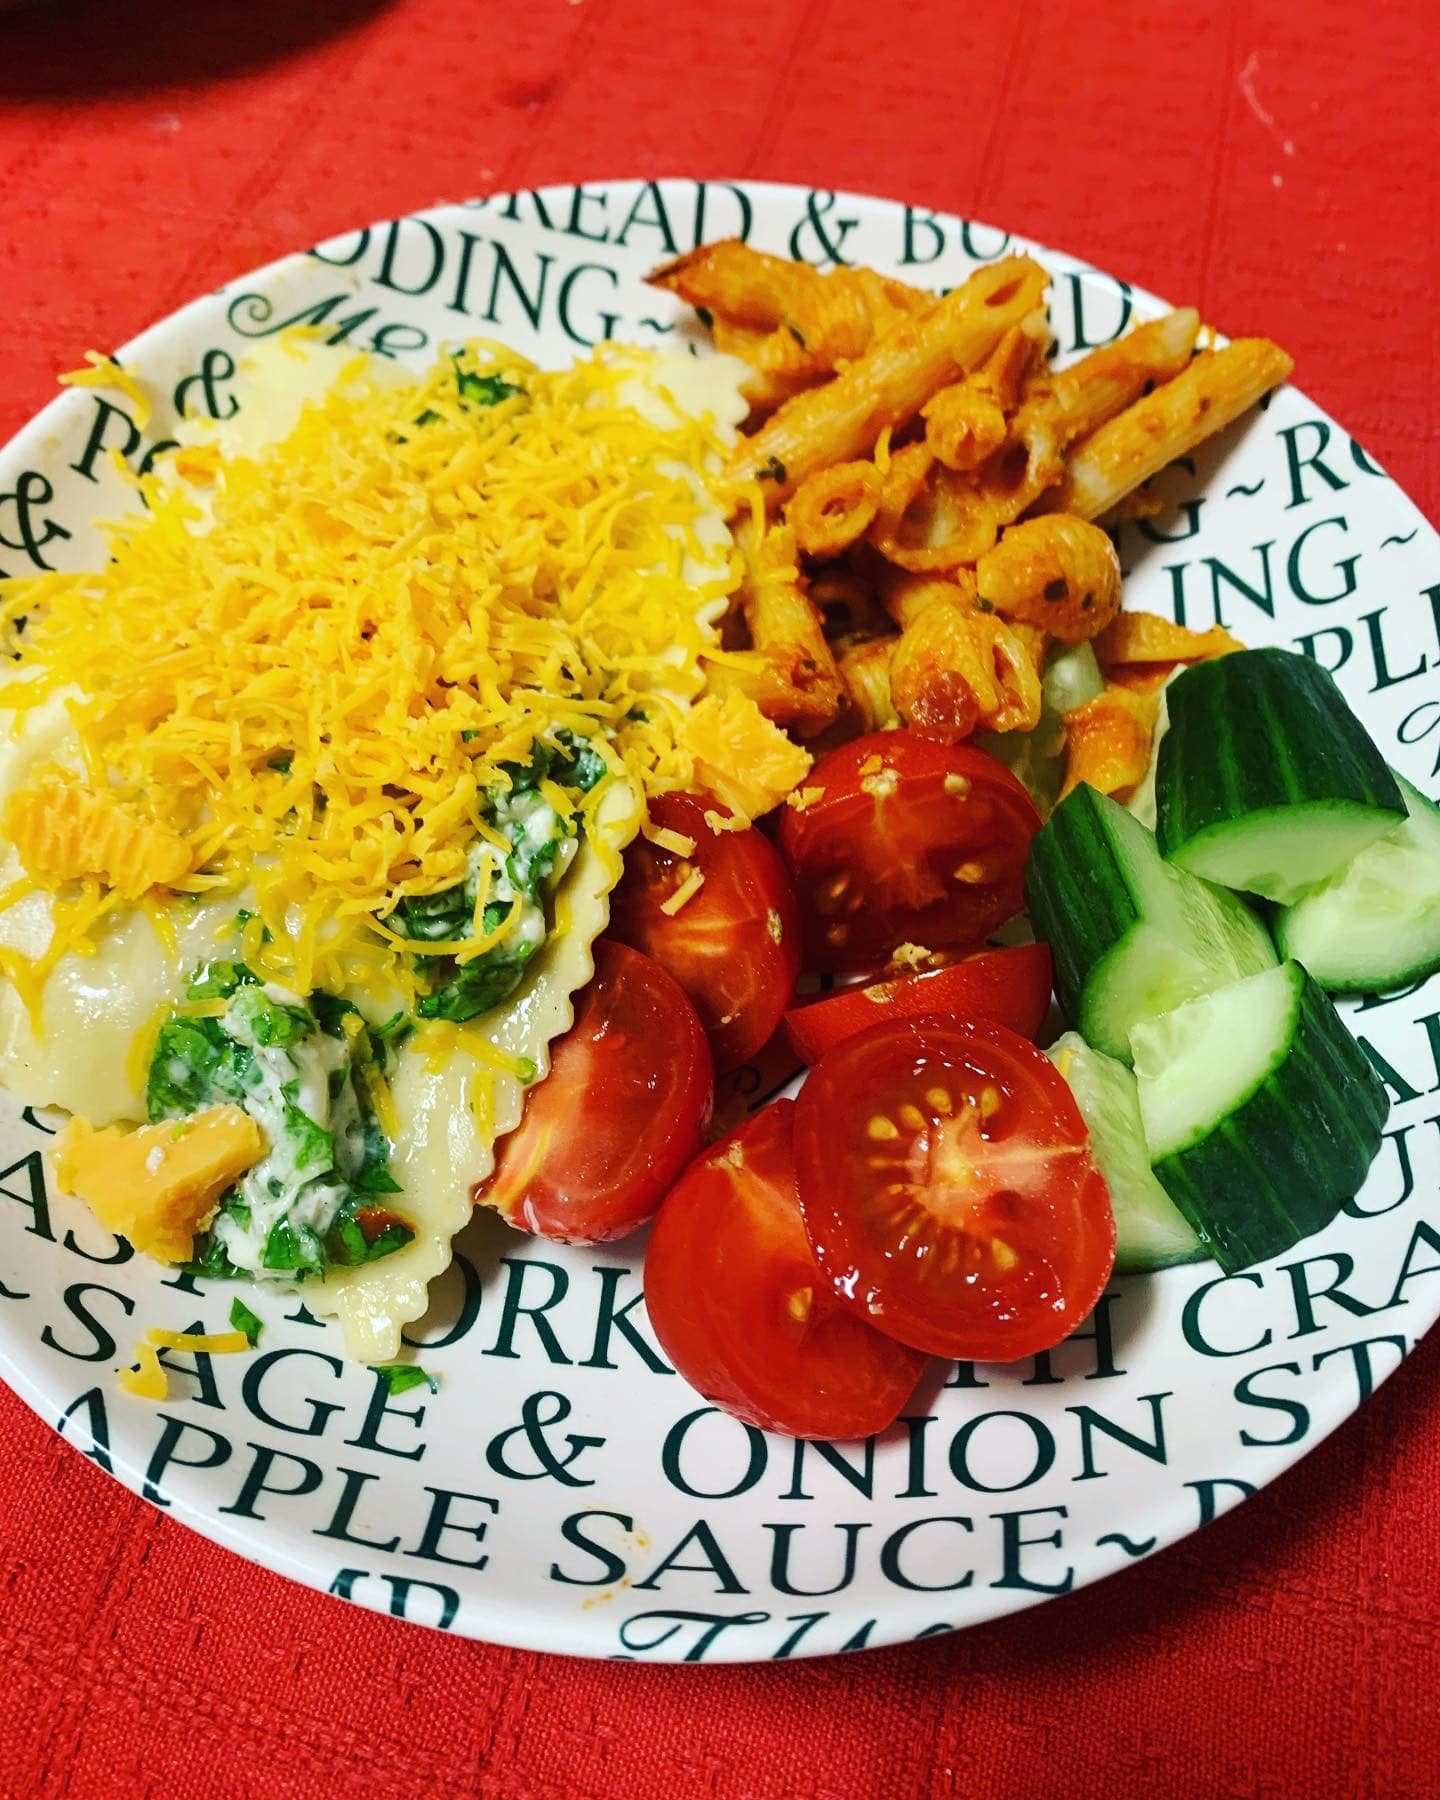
[785,943,1055,1064]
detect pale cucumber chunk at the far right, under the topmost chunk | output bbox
[1274,776,1440,994]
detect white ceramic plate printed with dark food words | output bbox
[0,180,1440,1661]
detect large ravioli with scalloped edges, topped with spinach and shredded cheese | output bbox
[0,340,741,1361]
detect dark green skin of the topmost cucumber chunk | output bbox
[1156,648,1406,862]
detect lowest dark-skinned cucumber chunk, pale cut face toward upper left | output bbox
[1134,961,1390,1273]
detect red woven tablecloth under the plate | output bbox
[0,0,1440,1800]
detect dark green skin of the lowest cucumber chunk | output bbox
[1154,963,1390,1274]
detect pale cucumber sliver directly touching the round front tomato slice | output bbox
[1046,1031,1210,1274]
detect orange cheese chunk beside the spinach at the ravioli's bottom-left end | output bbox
[54,1107,265,1262]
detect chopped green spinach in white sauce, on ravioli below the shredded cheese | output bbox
[155,730,607,1282]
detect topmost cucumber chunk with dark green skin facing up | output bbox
[1156,650,1406,905]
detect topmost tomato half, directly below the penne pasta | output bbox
[779,731,1040,968]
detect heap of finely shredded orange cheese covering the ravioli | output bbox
[0,346,736,1003]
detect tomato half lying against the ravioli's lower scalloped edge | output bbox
[475,938,715,1244]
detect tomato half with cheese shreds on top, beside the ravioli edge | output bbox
[610,794,799,1073]
